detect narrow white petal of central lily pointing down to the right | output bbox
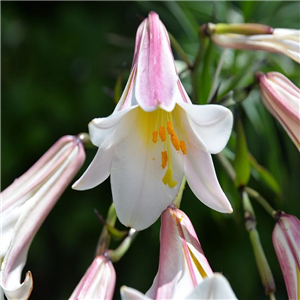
[184,143,232,213]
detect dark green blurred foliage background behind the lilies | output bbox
[0,0,300,300]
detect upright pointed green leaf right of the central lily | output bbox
[233,117,250,187]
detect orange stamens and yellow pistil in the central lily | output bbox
[149,109,186,188]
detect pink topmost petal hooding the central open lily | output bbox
[134,12,178,111]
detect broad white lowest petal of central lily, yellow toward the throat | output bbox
[111,108,183,230]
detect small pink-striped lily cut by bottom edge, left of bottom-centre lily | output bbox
[69,254,116,300]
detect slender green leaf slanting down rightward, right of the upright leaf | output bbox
[248,153,281,196]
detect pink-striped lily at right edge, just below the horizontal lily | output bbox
[257,72,300,151]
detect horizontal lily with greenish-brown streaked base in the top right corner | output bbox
[207,23,300,63]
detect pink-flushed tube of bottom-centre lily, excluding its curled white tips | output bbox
[146,207,213,299]
